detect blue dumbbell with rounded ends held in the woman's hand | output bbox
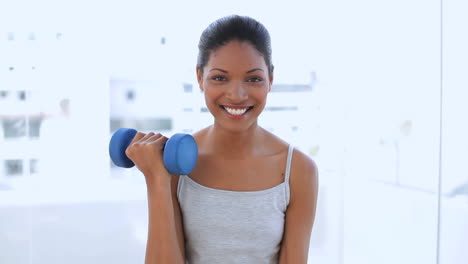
[109,128,198,175]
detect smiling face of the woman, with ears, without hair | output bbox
[197,41,273,132]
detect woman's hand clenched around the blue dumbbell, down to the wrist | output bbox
[125,132,171,184]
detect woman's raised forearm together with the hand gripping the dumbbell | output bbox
[125,132,185,264]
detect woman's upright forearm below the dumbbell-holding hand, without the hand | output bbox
[145,176,185,264]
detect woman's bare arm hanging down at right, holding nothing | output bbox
[279,151,318,264]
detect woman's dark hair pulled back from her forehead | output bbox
[197,15,274,75]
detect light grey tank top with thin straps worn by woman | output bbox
[177,145,293,264]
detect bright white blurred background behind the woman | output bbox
[0,0,468,264]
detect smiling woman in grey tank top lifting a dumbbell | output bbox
[126,16,318,264]
